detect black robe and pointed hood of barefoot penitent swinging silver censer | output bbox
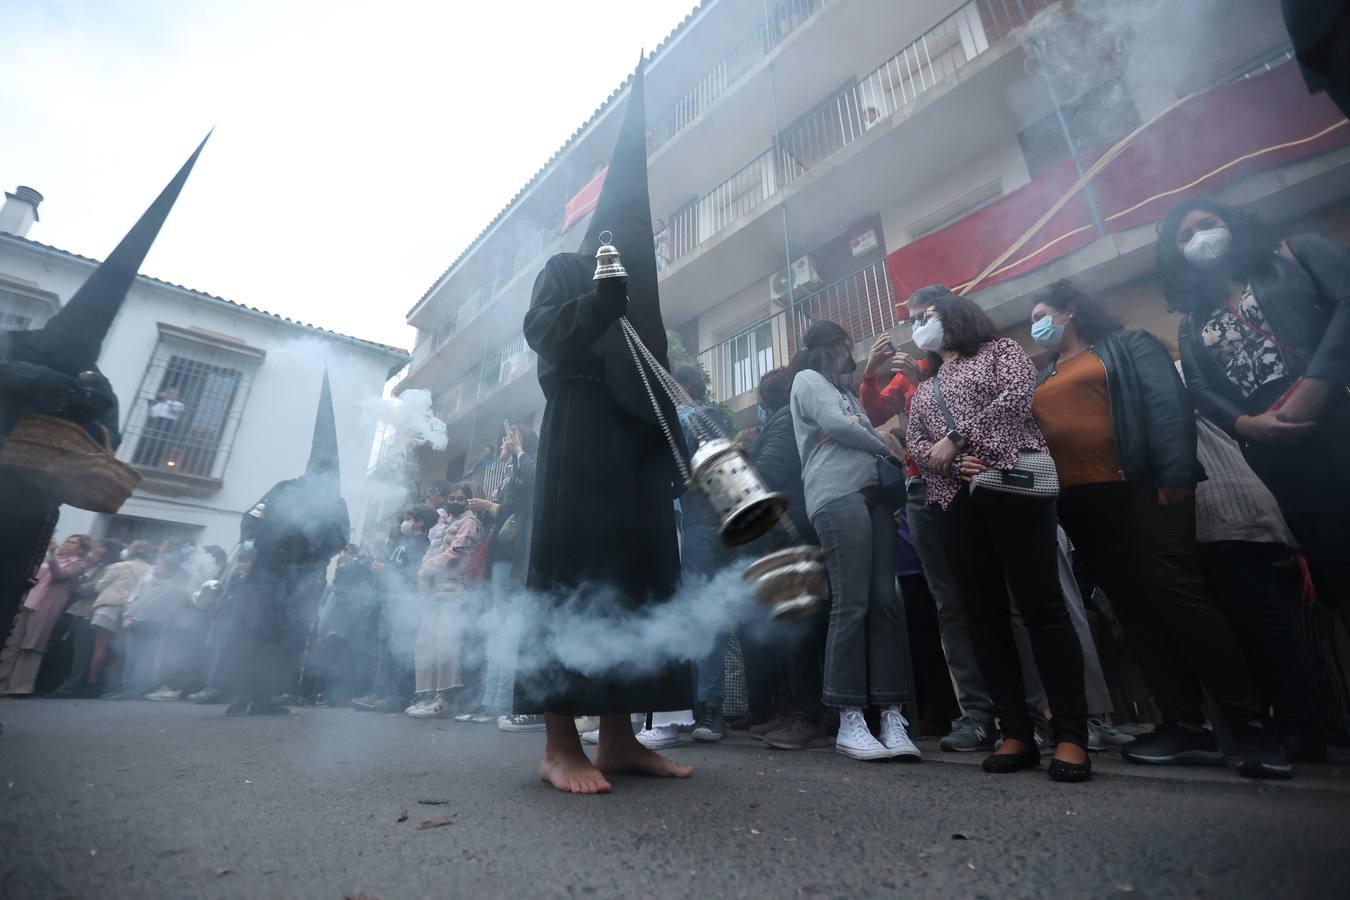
[516,59,694,715]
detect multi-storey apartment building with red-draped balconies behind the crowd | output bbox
[401,0,1350,478]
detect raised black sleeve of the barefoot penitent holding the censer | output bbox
[524,256,625,366]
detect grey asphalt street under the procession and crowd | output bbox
[0,700,1350,899]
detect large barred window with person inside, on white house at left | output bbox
[124,324,262,480]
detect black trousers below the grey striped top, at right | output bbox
[1199,541,1318,731]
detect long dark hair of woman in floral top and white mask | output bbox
[1154,197,1276,313]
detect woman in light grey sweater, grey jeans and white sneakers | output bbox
[791,321,919,761]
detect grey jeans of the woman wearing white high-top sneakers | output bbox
[811,493,913,707]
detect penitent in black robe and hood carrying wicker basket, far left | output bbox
[0,135,209,634]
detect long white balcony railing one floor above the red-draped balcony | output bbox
[657,0,1054,264]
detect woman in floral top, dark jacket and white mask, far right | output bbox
[1157,200,1350,631]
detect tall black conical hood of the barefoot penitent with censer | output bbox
[578,61,666,360]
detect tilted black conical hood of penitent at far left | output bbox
[31,134,211,371]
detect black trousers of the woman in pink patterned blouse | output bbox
[941,488,1088,748]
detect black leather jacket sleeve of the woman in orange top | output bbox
[1122,331,1197,487]
